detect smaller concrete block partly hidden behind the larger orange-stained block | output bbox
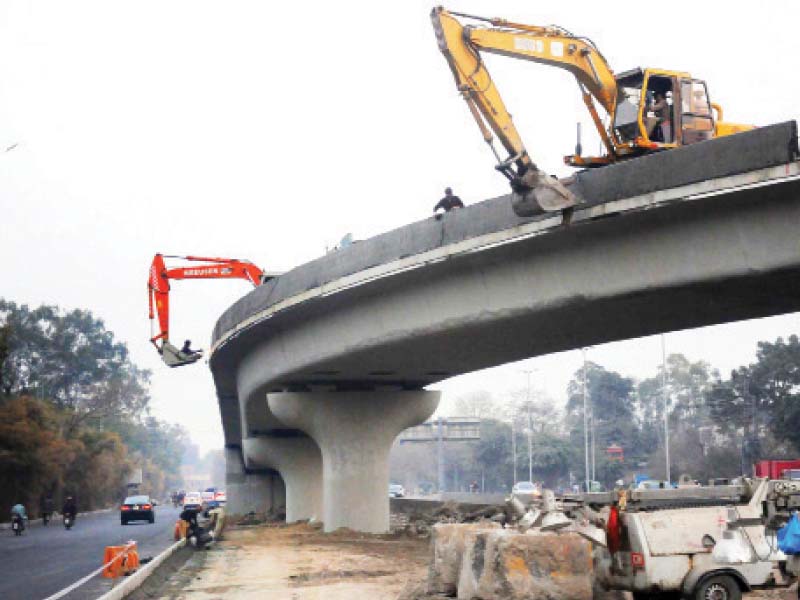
[428,521,500,596]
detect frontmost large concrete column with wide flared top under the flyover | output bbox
[267,391,440,533]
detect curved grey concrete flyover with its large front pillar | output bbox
[210,122,800,531]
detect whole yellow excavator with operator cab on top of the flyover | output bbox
[431,6,753,212]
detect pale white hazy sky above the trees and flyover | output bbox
[0,0,800,449]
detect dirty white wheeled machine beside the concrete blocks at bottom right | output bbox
[595,479,800,600]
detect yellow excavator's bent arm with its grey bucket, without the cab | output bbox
[431,7,617,211]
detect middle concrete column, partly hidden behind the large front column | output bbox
[242,434,322,523]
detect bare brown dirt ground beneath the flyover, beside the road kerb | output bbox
[153,524,797,600]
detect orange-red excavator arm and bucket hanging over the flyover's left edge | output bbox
[147,254,275,367]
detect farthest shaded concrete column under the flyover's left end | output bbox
[225,448,283,516]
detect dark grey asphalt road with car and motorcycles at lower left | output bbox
[0,506,180,600]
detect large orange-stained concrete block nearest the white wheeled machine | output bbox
[458,529,592,600]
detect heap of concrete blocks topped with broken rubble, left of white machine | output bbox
[427,490,605,600]
